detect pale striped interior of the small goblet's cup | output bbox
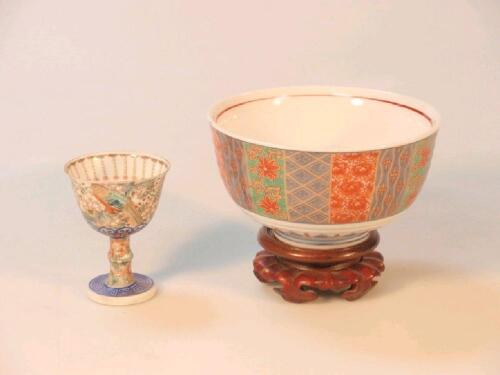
[65,153,169,184]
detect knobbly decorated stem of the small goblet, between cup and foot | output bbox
[106,237,134,288]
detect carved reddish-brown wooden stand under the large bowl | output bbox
[253,227,384,303]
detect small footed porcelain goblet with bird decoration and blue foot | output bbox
[64,153,170,305]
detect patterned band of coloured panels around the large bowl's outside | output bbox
[212,128,436,224]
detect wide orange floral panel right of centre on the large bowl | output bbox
[330,152,379,224]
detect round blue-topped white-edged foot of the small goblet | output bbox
[87,273,156,306]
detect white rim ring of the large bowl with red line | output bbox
[208,86,441,153]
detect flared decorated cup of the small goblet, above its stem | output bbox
[65,153,169,238]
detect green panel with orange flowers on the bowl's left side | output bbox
[245,143,288,220]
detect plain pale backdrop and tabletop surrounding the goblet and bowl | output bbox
[0,0,500,375]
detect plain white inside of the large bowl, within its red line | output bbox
[217,94,432,150]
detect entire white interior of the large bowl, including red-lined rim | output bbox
[212,88,437,152]
